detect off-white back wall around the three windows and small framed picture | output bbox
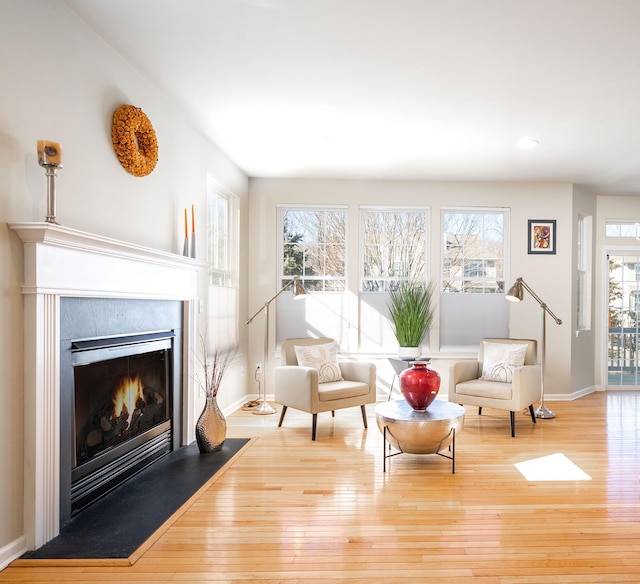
[248,178,593,399]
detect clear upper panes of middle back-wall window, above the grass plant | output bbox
[360,207,429,292]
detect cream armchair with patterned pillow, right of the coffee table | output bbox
[449,339,542,436]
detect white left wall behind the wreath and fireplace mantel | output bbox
[0,0,248,568]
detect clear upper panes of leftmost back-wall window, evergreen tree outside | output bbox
[280,208,347,292]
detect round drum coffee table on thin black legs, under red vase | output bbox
[375,399,464,474]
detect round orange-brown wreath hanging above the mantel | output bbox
[111,105,158,176]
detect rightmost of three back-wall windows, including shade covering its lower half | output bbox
[439,208,509,351]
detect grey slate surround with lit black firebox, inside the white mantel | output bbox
[60,298,183,526]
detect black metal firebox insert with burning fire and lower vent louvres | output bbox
[71,331,174,515]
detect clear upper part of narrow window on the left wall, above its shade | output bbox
[207,184,235,286]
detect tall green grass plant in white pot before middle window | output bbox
[387,280,434,359]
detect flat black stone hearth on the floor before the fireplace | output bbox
[22,438,248,560]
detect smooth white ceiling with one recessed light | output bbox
[64,0,640,195]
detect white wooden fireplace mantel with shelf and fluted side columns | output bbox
[9,223,207,549]
